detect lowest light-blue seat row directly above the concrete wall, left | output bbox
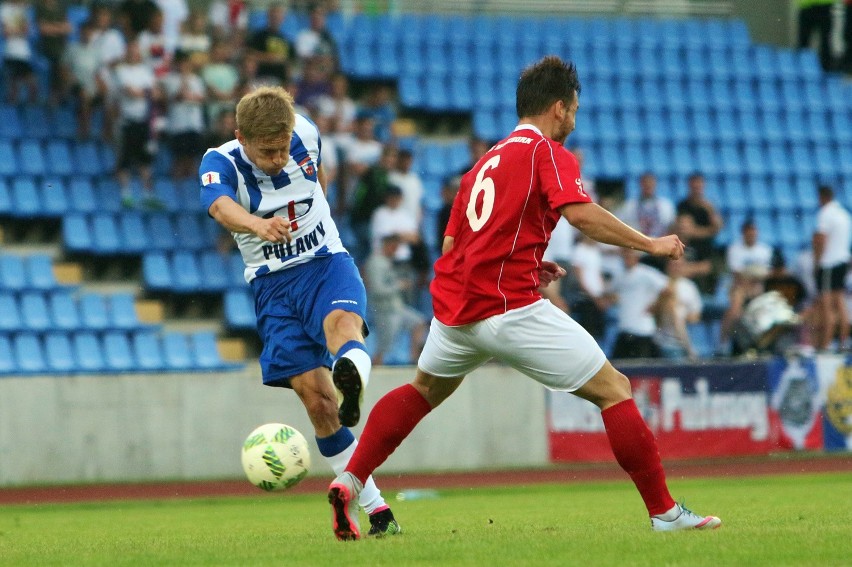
[0,330,237,375]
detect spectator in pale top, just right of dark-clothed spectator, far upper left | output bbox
[62,19,106,138]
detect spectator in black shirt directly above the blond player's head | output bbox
[246,2,296,86]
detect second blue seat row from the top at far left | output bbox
[0,136,116,177]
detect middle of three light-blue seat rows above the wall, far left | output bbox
[0,289,151,332]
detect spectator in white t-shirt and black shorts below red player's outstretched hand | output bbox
[612,248,669,359]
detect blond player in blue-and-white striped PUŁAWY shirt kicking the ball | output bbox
[199,87,400,535]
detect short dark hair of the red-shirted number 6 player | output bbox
[515,55,580,118]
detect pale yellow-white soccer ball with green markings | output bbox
[242,423,311,491]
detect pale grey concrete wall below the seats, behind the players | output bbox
[0,367,549,486]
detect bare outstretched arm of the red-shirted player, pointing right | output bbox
[560,203,683,259]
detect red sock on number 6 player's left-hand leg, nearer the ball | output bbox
[346,384,432,482]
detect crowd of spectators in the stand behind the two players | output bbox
[0,0,852,363]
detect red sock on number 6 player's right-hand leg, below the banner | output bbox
[601,399,675,516]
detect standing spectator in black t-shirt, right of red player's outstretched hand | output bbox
[675,173,723,293]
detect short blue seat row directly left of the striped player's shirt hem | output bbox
[142,250,246,293]
